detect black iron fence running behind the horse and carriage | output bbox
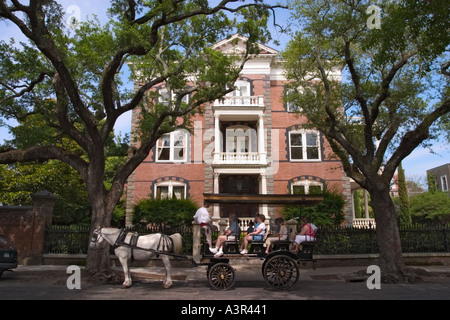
[44,225,450,255]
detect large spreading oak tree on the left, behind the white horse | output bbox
[0,0,278,275]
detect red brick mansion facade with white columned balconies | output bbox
[127,35,352,222]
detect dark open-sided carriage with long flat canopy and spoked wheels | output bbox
[199,194,323,290]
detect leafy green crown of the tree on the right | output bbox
[283,0,450,184]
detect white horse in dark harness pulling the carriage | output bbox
[90,228,182,289]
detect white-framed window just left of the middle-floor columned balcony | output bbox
[156,130,189,162]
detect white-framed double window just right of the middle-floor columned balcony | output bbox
[289,130,321,161]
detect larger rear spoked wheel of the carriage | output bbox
[262,255,300,290]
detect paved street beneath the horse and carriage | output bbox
[0,264,450,301]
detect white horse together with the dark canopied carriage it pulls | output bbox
[91,194,323,290]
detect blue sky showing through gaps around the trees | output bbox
[0,0,450,184]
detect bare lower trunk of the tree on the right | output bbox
[369,188,407,283]
